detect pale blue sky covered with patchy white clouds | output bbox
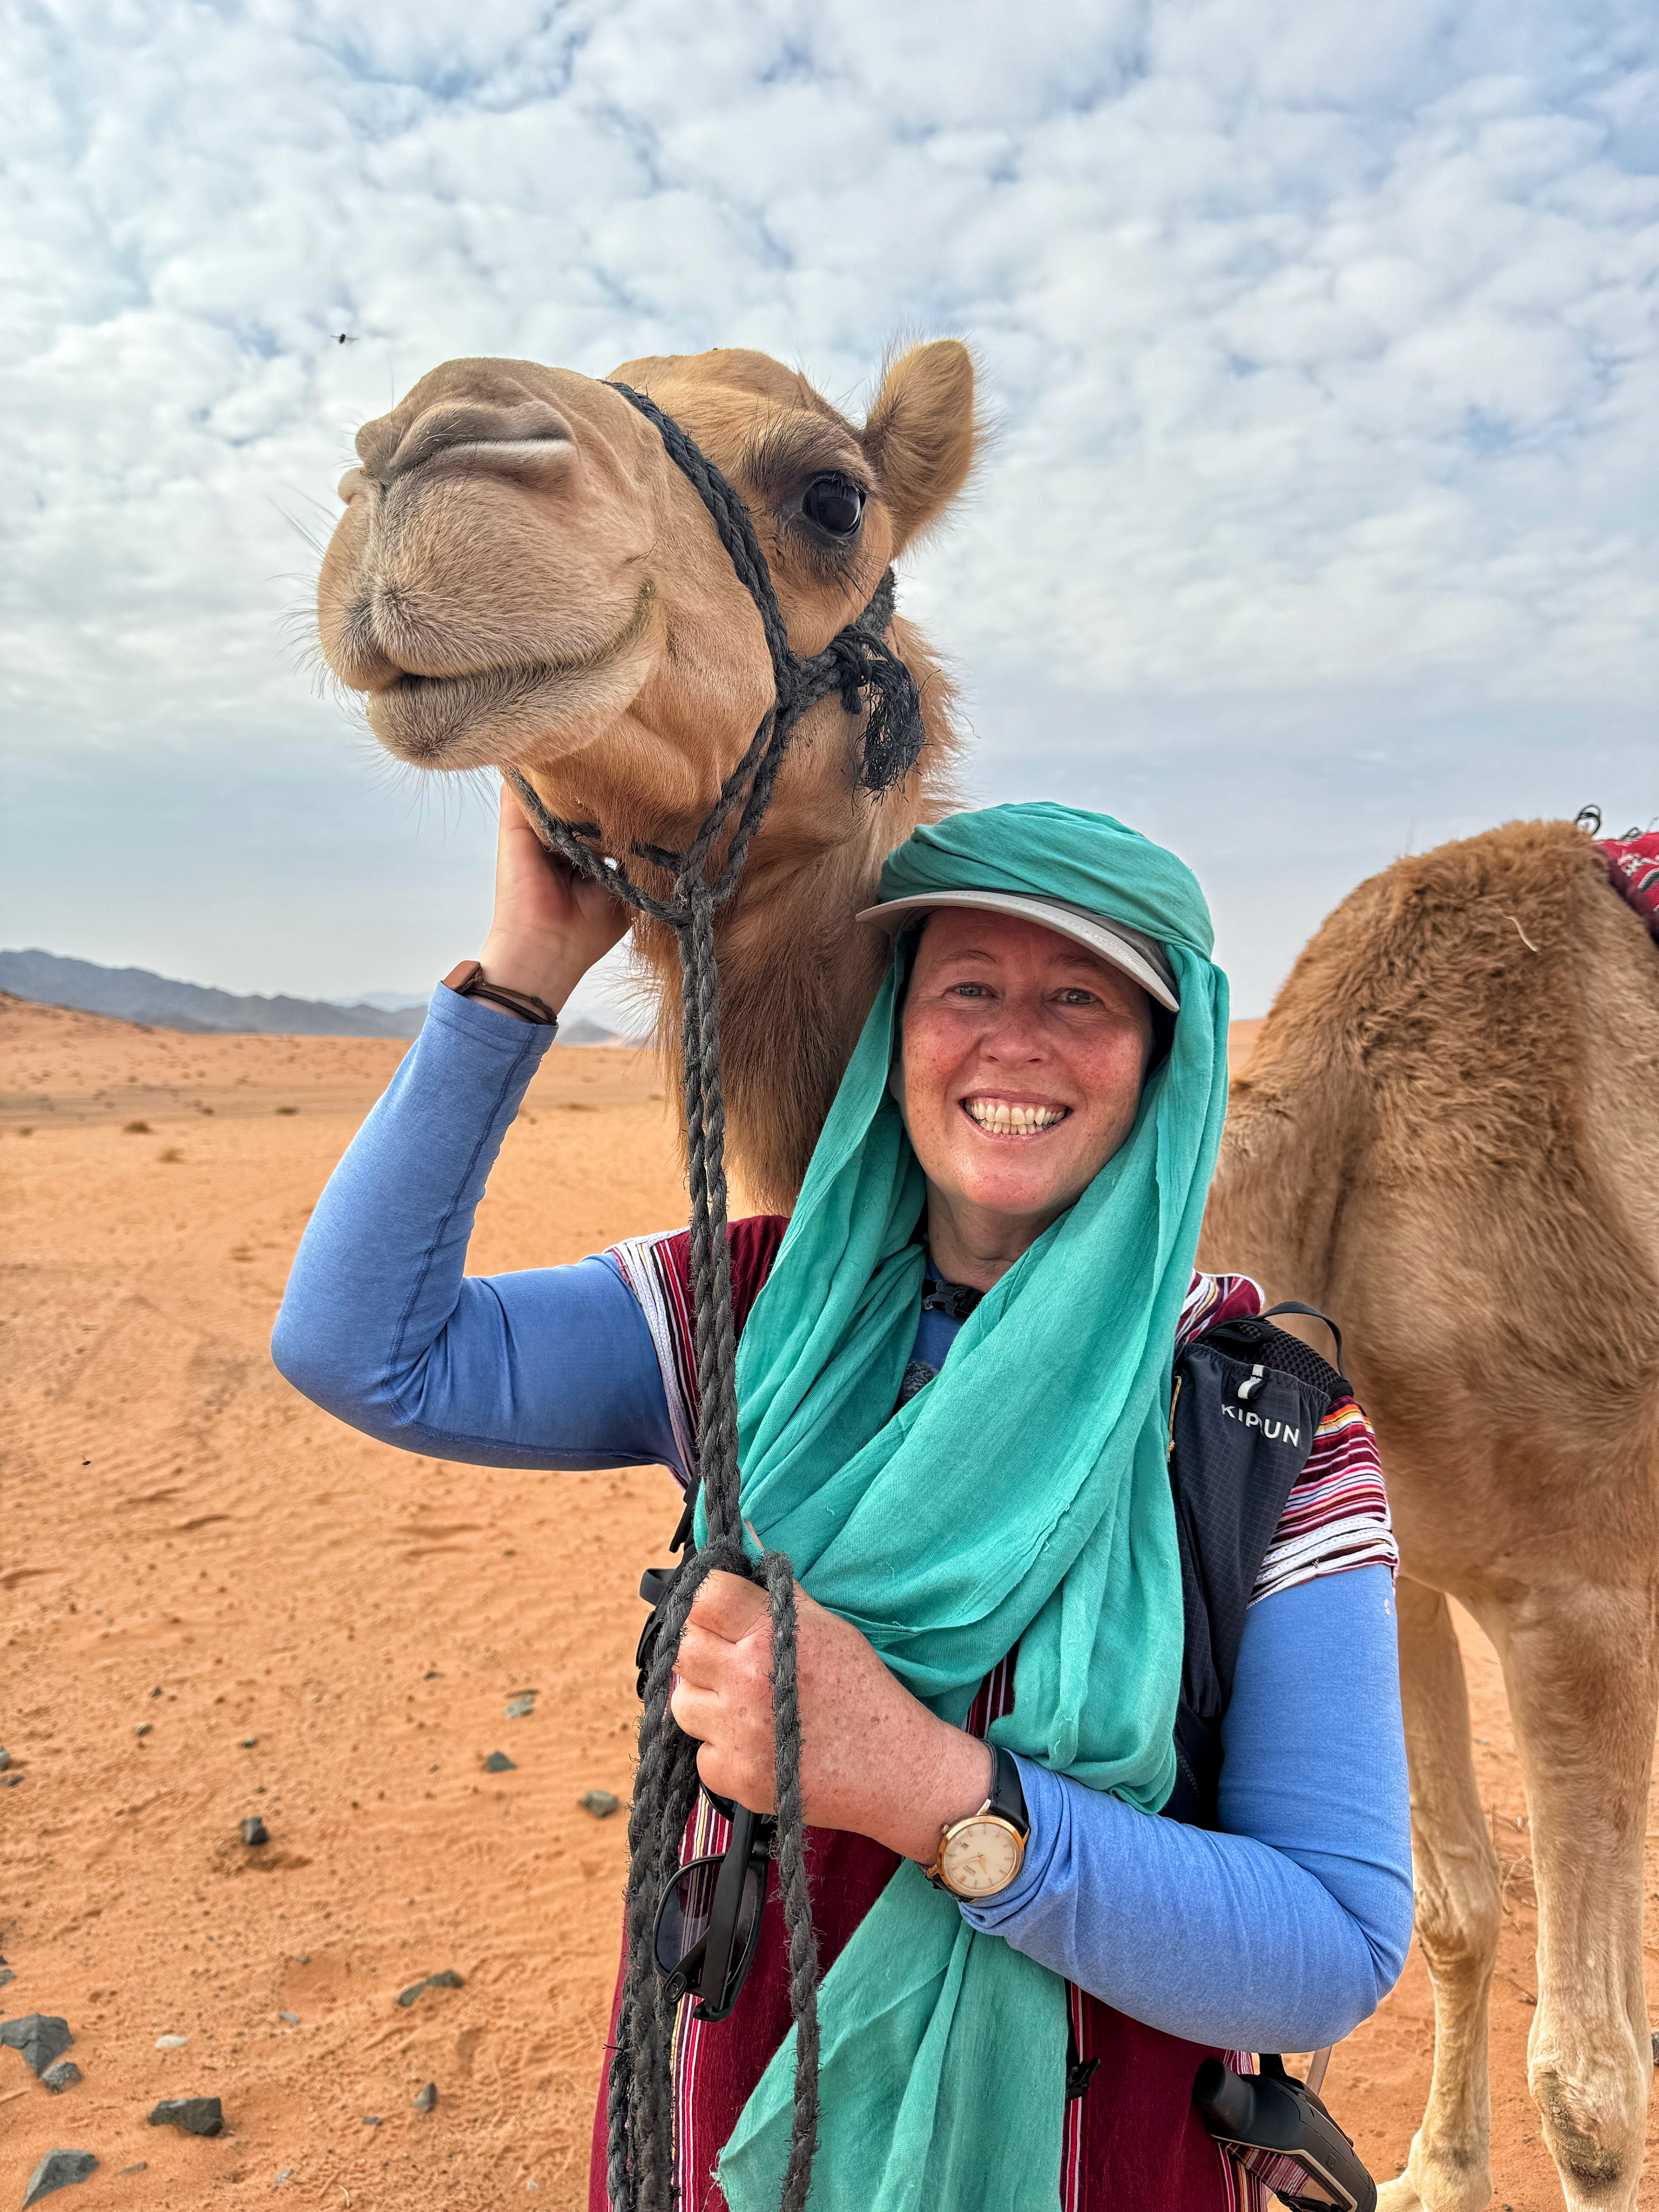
[0,0,1659,1013]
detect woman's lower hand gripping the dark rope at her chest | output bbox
[672,1573,991,1865]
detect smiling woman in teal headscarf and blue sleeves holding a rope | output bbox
[274,796,1411,2212]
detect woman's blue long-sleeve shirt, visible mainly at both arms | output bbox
[272,987,1411,2051]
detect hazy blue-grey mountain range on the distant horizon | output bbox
[0,949,628,1044]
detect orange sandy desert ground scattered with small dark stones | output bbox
[0,998,1659,2212]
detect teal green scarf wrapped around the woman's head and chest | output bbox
[719,803,1228,2212]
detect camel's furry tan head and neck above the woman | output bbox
[319,341,975,1206]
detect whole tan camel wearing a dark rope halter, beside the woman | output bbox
[319,341,1659,2212]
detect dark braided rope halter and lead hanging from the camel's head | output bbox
[507,385,925,2212]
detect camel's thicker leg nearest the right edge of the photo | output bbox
[1493,1584,1659,2212]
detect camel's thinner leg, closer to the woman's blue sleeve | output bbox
[1376,1575,1504,2212]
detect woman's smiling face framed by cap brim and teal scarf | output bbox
[894,907,1152,1290]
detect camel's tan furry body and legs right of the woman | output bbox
[1203,823,1659,2212]
